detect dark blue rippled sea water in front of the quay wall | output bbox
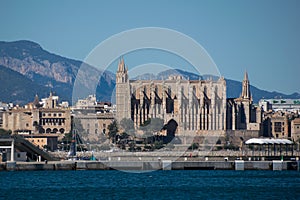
[0,170,300,200]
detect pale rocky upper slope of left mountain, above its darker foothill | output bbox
[0,40,115,102]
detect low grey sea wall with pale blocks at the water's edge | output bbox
[0,160,300,171]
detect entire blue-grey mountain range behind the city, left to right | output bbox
[0,40,300,105]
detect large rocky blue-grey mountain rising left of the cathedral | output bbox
[0,40,115,104]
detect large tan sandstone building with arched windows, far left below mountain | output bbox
[2,93,71,134]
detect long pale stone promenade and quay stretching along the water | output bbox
[0,151,300,171]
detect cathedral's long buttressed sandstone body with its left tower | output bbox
[116,58,226,134]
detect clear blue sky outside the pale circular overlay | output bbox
[0,0,300,93]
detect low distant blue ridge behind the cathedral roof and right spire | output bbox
[133,69,300,103]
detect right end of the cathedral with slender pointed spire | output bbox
[226,72,262,132]
